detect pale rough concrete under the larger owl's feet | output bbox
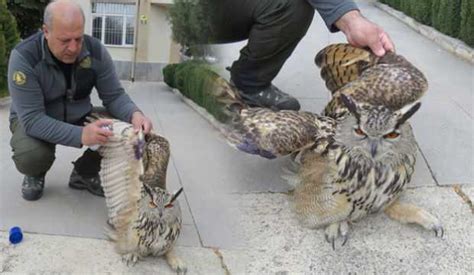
[235,187,474,274]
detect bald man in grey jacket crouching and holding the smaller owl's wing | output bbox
[8,0,152,201]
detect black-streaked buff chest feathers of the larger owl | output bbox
[323,147,415,219]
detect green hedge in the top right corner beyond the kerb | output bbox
[380,0,474,47]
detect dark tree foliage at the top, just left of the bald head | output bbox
[7,0,49,38]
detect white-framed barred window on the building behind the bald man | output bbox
[90,3,137,48]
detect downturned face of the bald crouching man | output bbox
[43,18,84,64]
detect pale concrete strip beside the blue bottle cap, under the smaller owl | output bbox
[0,232,236,274]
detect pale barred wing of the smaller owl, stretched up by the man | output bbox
[98,120,144,232]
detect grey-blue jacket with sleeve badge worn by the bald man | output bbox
[8,32,139,147]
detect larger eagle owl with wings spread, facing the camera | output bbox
[228,44,443,248]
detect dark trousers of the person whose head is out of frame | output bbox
[209,0,314,92]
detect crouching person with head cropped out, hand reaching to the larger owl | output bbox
[210,0,394,110]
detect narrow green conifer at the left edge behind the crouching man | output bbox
[0,0,19,97]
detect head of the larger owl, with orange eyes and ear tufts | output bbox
[336,95,421,159]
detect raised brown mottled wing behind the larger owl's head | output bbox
[315,44,428,118]
